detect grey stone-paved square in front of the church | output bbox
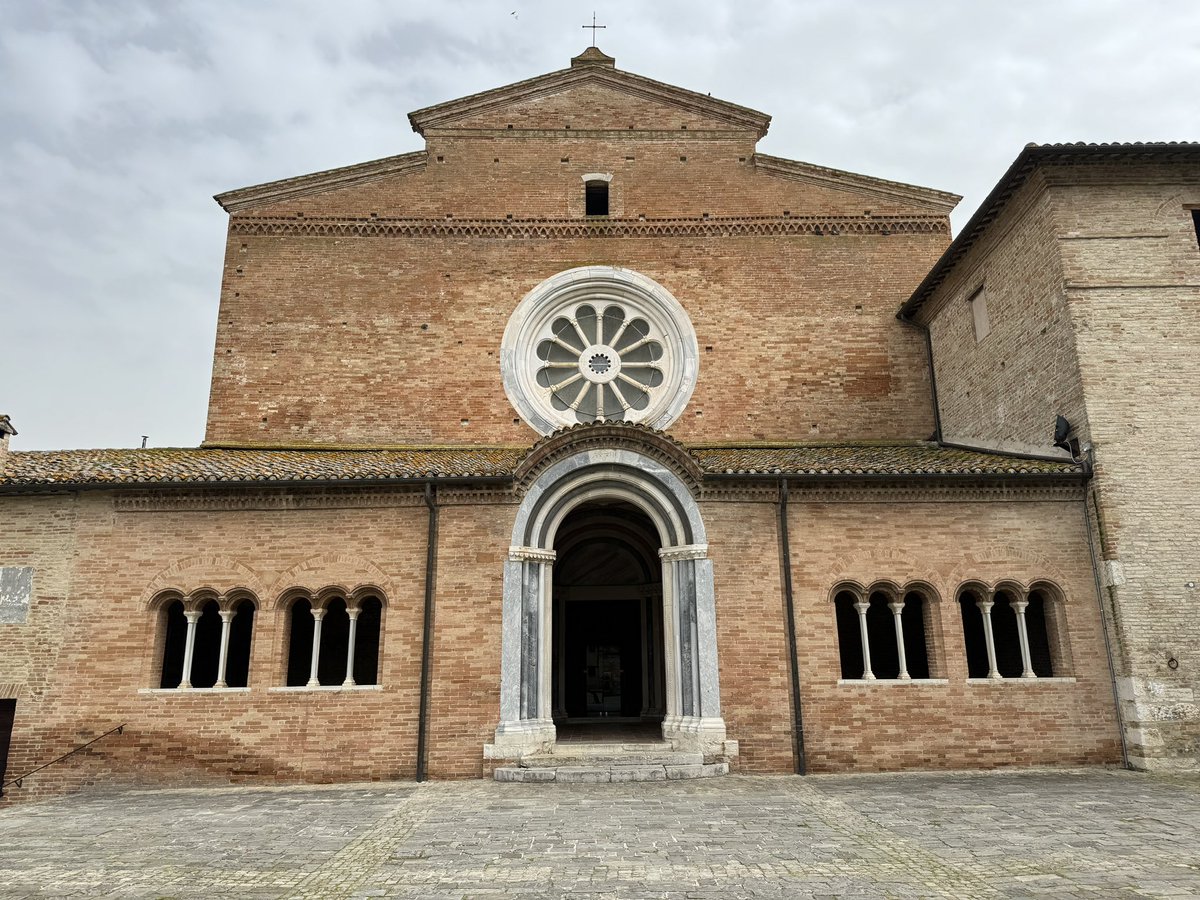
[0,769,1200,900]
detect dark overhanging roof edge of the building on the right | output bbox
[896,140,1200,320]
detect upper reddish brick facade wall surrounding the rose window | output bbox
[206,81,948,444]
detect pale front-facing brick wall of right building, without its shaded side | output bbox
[1048,164,1200,768]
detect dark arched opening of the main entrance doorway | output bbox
[551,500,666,732]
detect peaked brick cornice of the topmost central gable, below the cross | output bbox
[408,50,770,138]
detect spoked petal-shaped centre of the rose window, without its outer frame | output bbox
[538,304,662,422]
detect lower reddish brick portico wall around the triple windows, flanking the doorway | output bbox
[4,494,1118,797]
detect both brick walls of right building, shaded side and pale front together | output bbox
[922,158,1200,768]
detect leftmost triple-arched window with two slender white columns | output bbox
[158,590,254,690]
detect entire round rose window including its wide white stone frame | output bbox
[500,265,700,434]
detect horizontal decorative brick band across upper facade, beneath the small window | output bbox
[229,215,950,239]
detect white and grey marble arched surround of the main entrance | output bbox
[488,448,725,758]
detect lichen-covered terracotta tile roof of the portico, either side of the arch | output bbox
[0,442,1082,487]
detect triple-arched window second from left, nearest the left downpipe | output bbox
[286,593,383,688]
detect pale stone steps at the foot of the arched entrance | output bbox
[494,726,730,784]
